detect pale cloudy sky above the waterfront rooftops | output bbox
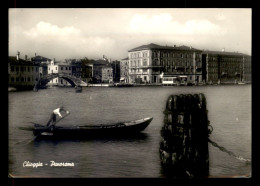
[8,8,252,60]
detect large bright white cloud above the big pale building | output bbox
[128,13,225,35]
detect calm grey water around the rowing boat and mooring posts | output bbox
[9,85,252,178]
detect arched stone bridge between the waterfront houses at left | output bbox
[36,73,87,89]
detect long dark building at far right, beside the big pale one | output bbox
[202,51,251,84]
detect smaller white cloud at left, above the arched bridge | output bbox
[24,21,81,37]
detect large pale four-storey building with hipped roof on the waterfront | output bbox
[128,43,202,84]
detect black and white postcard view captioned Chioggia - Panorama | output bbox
[8,8,252,178]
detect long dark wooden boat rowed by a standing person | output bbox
[19,117,153,136]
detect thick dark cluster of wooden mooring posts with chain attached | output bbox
[159,94,209,177]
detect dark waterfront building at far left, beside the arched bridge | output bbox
[8,53,39,89]
